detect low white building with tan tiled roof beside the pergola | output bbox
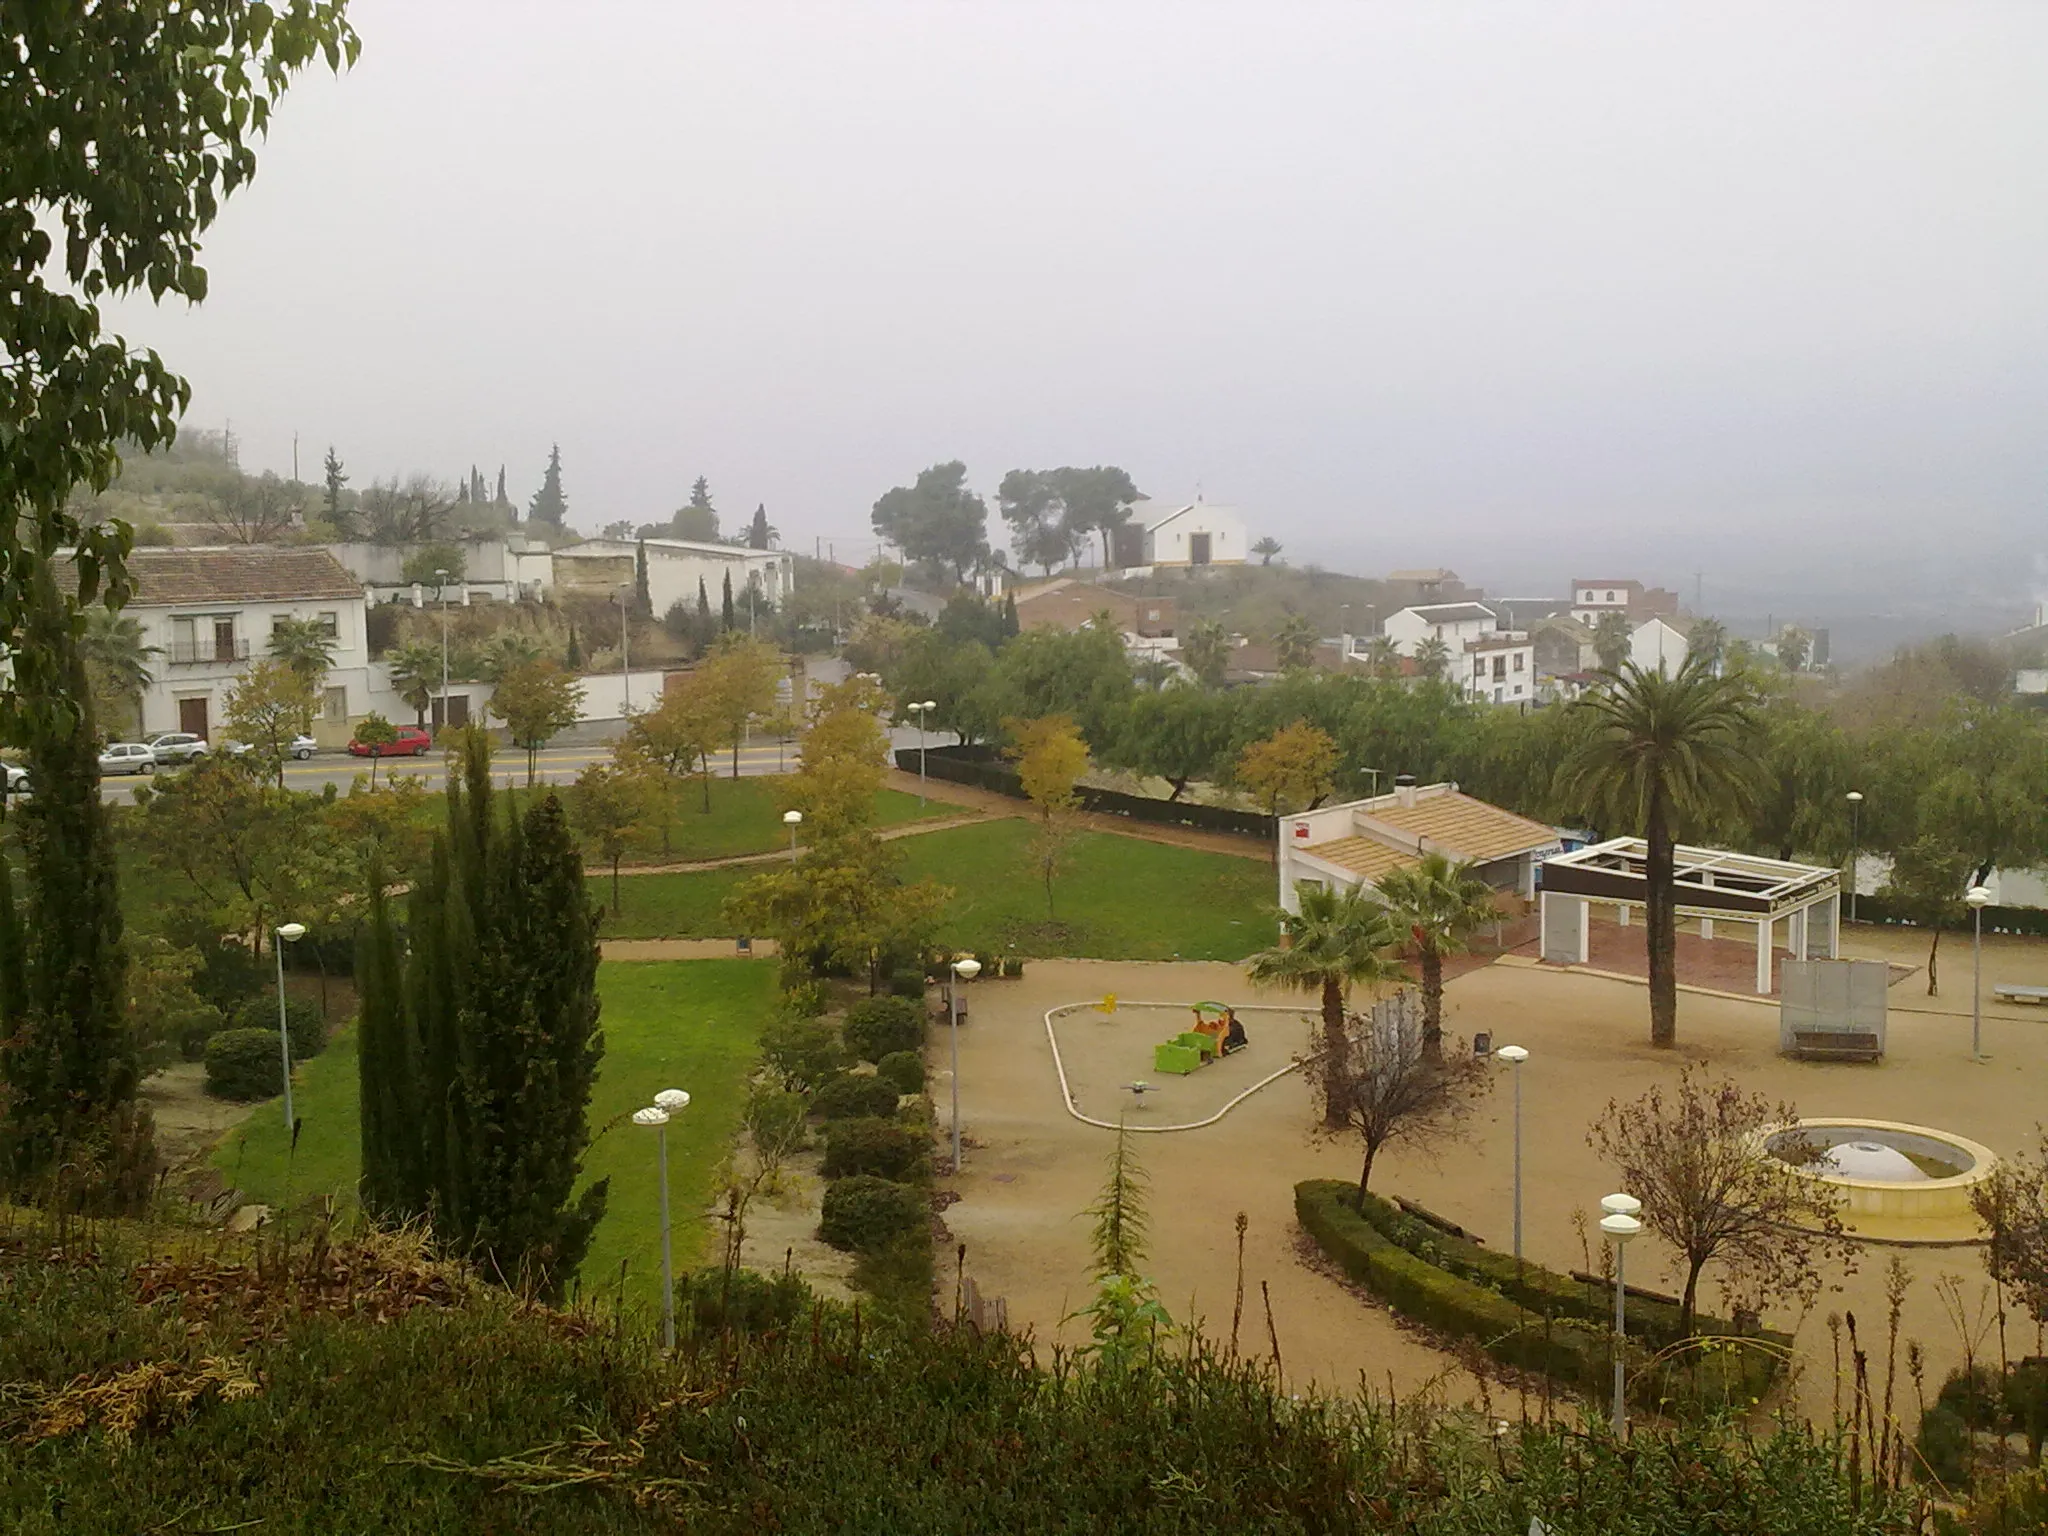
[1278,780,1563,911]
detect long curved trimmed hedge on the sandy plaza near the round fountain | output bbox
[1294,1180,1788,1407]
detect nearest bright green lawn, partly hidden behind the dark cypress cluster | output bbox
[213,962,774,1298]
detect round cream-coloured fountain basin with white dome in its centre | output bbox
[1763,1118,1997,1243]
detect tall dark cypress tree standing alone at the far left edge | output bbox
[0,577,156,1210]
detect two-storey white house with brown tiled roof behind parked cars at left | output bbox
[123,545,373,745]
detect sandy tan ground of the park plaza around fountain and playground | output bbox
[932,958,2048,1417]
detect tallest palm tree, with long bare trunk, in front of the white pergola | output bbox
[1563,655,1759,1047]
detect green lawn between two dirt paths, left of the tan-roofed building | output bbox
[592,819,1274,961]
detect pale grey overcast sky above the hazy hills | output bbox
[108,0,2048,606]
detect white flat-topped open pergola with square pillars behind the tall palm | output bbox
[1542,838,1841,993]
